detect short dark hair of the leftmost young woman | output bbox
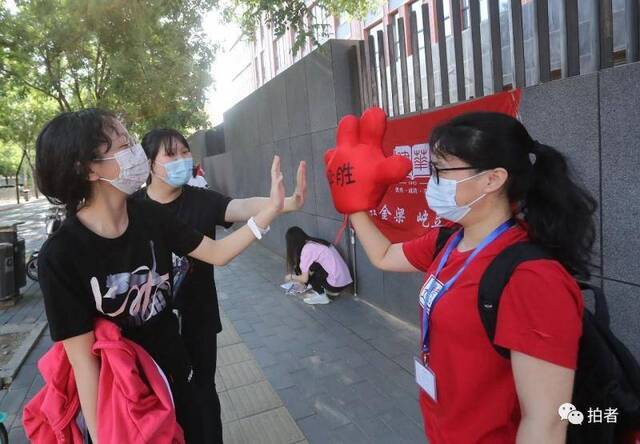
[36,108,118,213]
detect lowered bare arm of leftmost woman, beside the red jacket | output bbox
[63,332,100,444]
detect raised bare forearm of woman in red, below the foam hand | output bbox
[350,211,419,273]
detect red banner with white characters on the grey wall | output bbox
[370,89,520,243]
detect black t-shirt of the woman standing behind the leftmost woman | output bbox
[133,185,232,334]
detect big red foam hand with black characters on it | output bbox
[324,108,412,214]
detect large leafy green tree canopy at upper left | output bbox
[0,0,215,134]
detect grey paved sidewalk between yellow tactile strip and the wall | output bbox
[216,241,425,444]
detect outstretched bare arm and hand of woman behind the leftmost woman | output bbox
[224,161,307,222]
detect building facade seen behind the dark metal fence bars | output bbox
[225,0,629,110]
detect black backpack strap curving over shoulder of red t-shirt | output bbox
[478,242,552,359]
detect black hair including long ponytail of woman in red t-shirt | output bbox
[429,112,597,278]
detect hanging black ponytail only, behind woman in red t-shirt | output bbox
[524,142,597,278]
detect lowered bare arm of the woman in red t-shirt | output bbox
[511,351,575,444]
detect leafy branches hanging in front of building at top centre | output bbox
[221,0,382,54]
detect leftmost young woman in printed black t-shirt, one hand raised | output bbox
[36,109,296,442]
